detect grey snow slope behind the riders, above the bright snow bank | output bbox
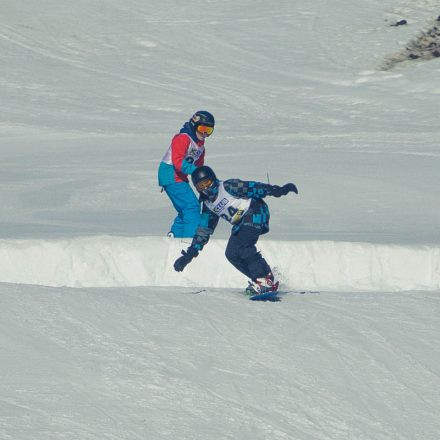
[0,0,440,244]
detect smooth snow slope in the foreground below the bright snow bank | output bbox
[0,285,440,440]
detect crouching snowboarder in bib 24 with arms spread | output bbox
[174,166,298,294]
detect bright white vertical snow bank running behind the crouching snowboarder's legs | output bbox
[0,236,440,291]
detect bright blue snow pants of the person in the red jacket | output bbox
[164,182,200,238]
